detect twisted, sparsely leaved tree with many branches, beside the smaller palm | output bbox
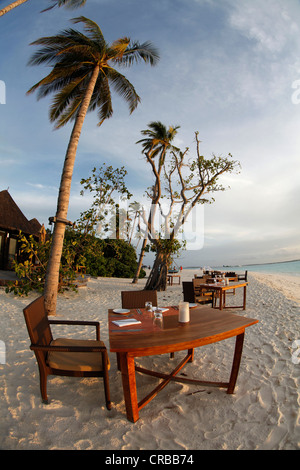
[145,132,240,290]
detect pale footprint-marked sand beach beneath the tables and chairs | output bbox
[0,270,300,451]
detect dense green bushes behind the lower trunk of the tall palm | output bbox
[6,229,145,296]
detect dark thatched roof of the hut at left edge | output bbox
[0,190,41,236]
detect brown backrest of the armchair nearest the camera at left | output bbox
[23,296,53,346]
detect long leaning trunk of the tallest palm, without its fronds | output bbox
[44,66,99,315]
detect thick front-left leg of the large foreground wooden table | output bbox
[120,353,139,423]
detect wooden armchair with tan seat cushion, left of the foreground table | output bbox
[23,296,111,410]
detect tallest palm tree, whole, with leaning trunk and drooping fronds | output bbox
[28,17,159,314]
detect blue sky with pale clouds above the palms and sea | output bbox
[0,0,300,266]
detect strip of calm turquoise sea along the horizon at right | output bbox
[185,260,300,276]
